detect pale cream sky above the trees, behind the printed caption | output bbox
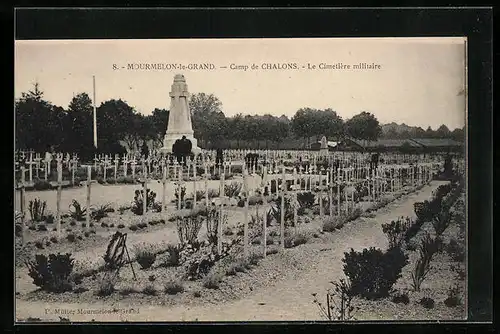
[14,37,466,129]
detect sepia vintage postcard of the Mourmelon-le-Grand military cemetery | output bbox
[14,37,467,322]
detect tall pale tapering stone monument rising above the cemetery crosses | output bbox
[161,74,201,154]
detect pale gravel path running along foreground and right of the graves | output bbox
[16,182,442,321]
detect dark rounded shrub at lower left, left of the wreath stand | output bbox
[26,253,74,293]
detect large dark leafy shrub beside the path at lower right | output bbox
[342,247,408,299]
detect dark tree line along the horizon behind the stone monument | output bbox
[15,83,463,153]
